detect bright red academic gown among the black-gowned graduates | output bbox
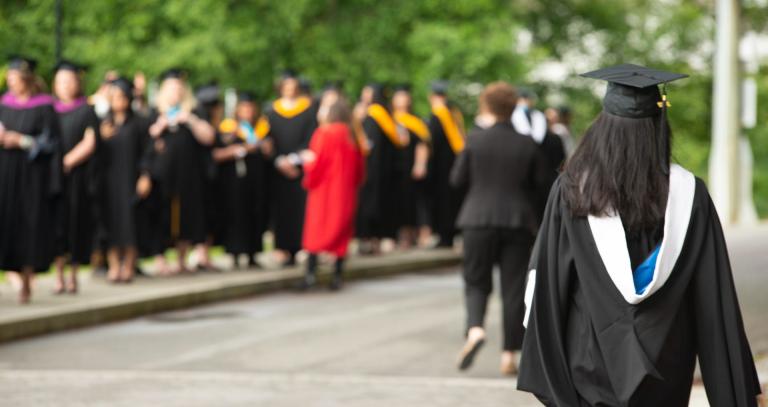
[303,123,365,257]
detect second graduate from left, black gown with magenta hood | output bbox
[53,61,99,294]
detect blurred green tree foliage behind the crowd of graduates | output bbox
[0,0,768,216]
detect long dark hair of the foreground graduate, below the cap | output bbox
[562,112,672,229]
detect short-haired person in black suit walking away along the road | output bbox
[451,82,547,374]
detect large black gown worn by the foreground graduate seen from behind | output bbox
[518,176,759,407]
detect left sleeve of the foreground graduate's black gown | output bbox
[517,181,579,406]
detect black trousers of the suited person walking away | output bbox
[463,228,533,351]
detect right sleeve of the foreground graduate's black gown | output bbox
[691,186,760,407]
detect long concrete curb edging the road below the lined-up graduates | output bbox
[0,250,461,342]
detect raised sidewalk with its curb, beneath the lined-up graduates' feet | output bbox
[0,250,460,342]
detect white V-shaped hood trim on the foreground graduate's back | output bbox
[588,165,696,304]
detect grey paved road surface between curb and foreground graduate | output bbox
[0,267,752,407]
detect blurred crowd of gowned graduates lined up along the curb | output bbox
[0,57,570,303]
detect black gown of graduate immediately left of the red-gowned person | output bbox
[266,106,317,253]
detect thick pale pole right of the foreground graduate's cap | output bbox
[709,0,741,225]
